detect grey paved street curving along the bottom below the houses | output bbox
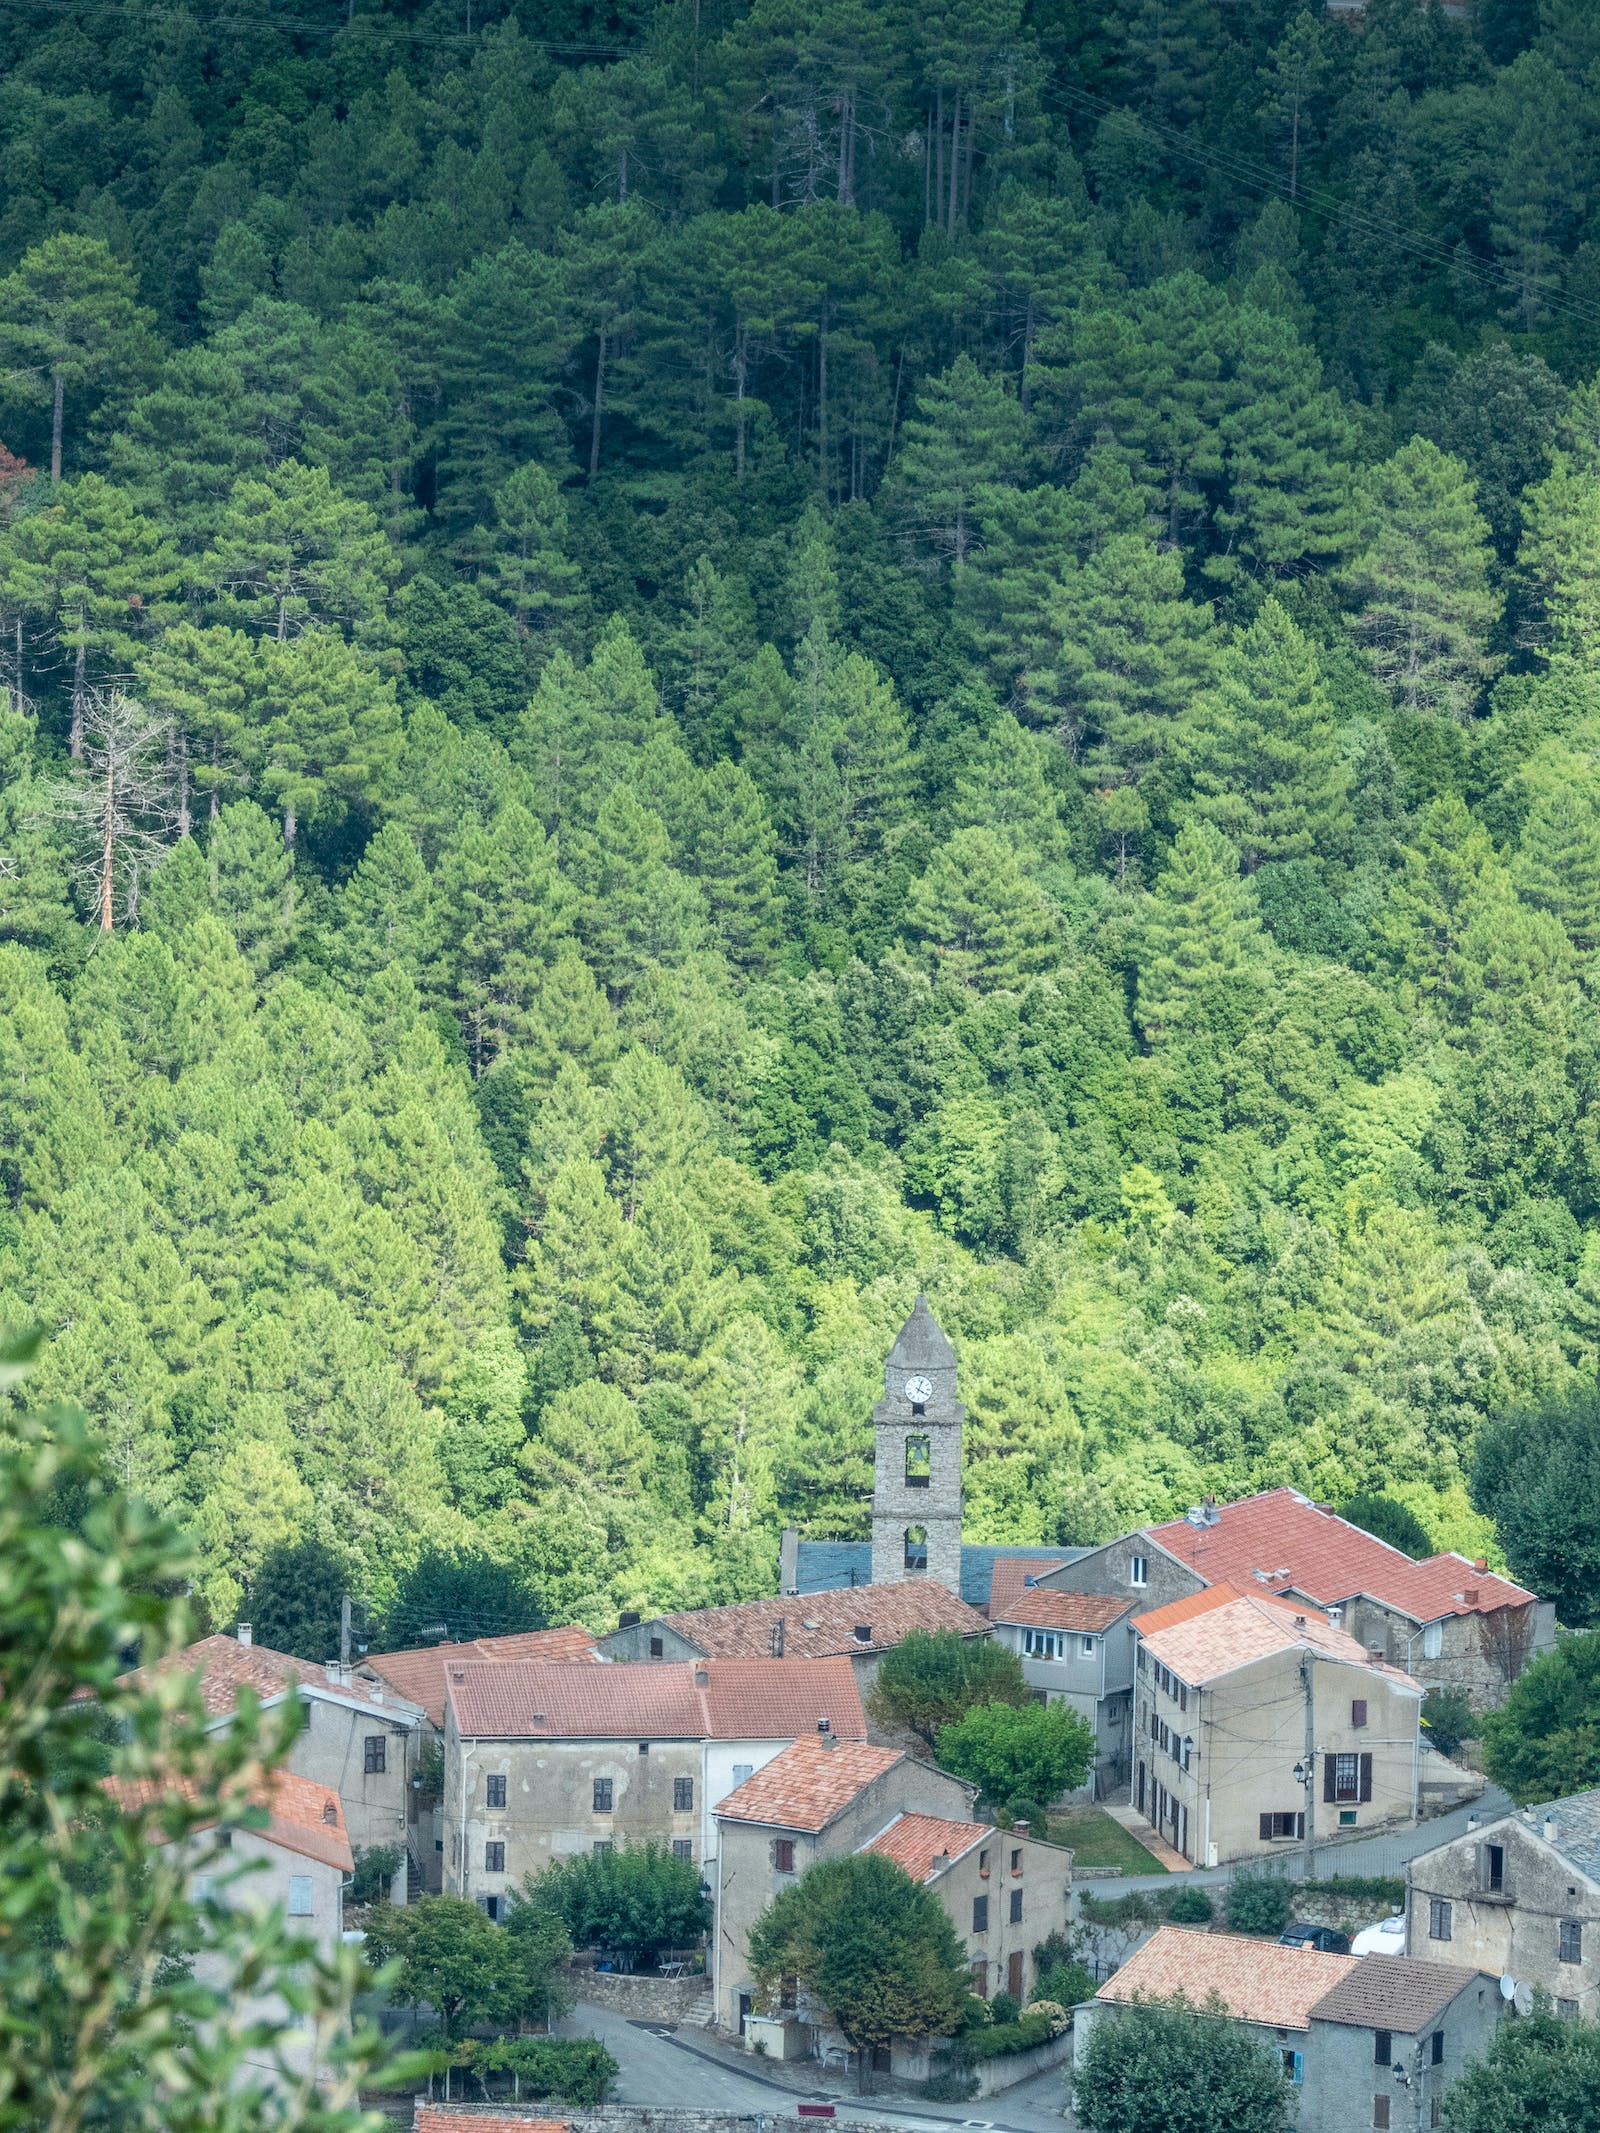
[559,2005,1065,2133]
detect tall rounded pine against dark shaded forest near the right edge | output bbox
[1344,437,1500,719]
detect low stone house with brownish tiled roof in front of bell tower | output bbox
[595,1578,990,1700]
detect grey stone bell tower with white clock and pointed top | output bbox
[873,1297,966,1595]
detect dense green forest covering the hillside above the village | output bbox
[0,0,1600,1625]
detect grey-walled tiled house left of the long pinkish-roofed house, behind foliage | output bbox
[120,1623,422,1903]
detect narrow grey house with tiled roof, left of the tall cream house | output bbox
[990,1557,1141,1800]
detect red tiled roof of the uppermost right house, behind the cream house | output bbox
[1148,1489,1534,1621]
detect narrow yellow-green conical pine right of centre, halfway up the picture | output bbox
[1139,823,1263,1043]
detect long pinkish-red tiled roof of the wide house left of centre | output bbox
[446,1659,866,1741]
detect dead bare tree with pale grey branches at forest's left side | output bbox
[51,689,173,934]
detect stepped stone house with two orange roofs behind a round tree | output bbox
[713,1738,1071,2080]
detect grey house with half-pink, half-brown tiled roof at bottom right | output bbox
[1073,1926,1502,2133]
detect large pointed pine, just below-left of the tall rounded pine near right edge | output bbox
[1188,599,1350,875]
